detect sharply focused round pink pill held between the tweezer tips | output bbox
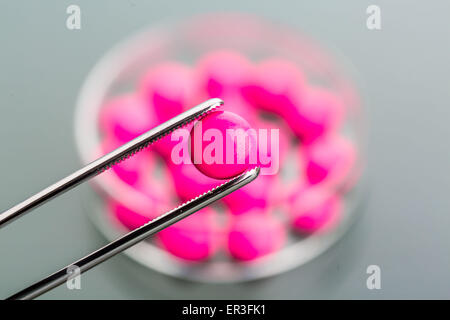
[190,111,257,179]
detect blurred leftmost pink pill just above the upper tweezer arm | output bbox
[99,94,156,143]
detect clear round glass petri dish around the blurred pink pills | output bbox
[75,13,366,283]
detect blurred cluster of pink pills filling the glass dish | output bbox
[99,50,357,262]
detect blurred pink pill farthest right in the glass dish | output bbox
[305,135,356,187]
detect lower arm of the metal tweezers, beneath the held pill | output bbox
[9,167,260,299]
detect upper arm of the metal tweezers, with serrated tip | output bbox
[0,98,223,228]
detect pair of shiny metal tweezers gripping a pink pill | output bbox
[0,99,259,299]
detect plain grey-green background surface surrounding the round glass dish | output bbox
[0,0,450,299]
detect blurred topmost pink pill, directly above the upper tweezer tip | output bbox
[197,50,251,97]
